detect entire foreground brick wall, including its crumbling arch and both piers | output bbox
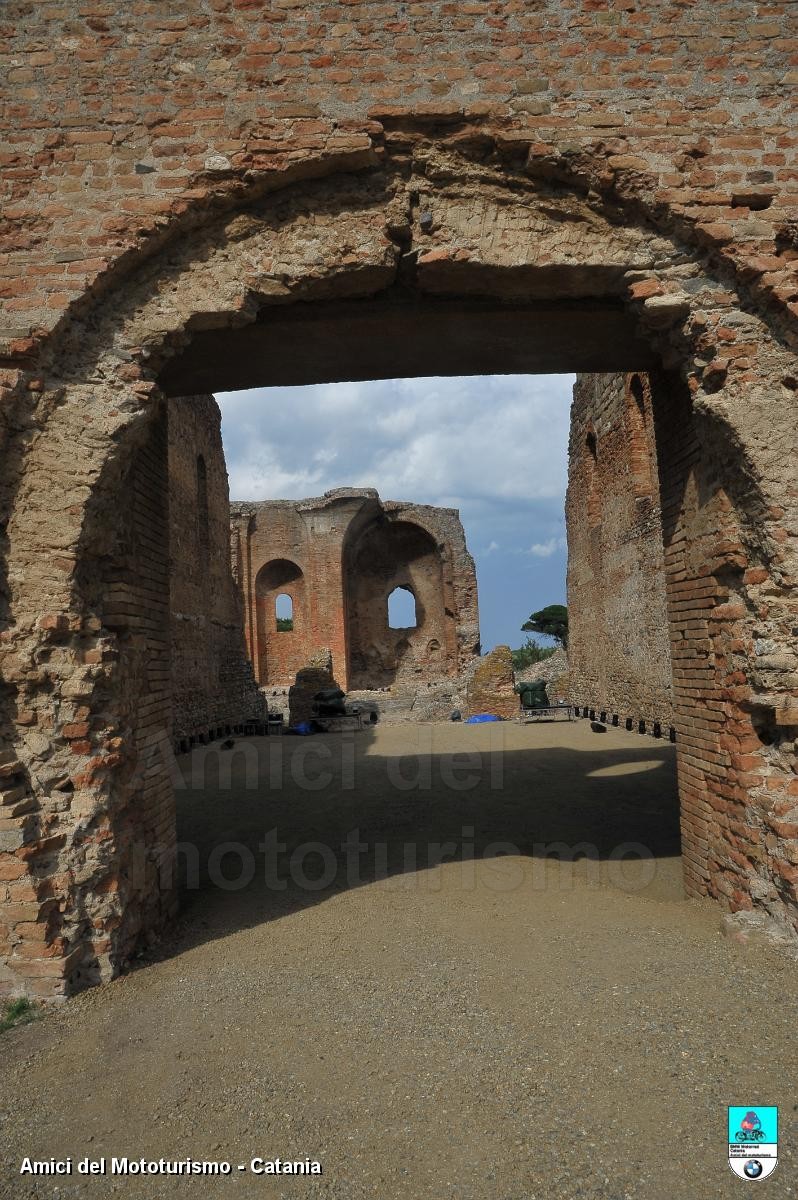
[0,0,798,997]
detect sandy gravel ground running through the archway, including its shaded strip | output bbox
[0,722,798,1200]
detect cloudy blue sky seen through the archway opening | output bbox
[216,376,574,649]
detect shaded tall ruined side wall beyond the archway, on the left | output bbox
[168,396,264,743]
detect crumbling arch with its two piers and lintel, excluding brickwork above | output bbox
[0,134,798,995]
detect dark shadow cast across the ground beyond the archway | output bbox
[152,726,680,956]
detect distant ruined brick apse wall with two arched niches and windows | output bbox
[230,488,479,689]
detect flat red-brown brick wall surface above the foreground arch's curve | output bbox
[0,0,797,352]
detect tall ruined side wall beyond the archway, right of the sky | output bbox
[565,373,673,732]
